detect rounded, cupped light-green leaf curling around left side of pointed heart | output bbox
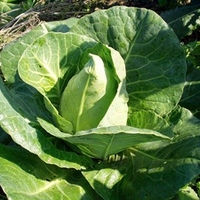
[18,33,96,133]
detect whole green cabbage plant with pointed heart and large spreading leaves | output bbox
[0,6,200,200]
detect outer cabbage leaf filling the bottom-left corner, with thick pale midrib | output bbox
[0,144,101,200]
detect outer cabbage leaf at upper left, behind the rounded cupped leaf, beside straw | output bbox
[0,18,77,83]
